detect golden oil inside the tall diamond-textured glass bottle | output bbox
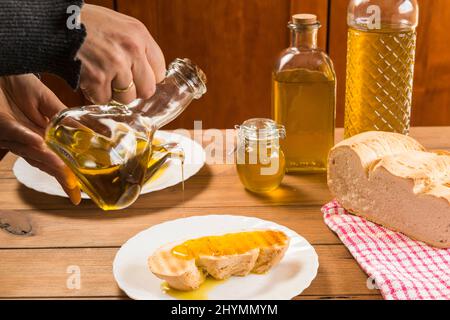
[345,26,416,138]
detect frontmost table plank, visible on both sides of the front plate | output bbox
[0,245,376,298]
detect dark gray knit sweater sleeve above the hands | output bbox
[0,0,86,89]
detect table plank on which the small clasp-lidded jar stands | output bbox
[0,172,330,213]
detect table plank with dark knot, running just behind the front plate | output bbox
[0,206,340,249]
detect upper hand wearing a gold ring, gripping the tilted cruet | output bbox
[78,4,166,104]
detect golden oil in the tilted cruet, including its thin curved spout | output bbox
[47,121,184,211]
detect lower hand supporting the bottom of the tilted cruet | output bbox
[0,75,81,205]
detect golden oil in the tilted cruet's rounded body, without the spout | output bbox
[46,107,151,210]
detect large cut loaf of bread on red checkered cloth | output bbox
[328,132,450,248]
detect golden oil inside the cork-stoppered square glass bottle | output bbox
[273,69,336,172]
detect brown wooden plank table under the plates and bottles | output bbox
[0,127,450,299]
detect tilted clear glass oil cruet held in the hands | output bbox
[46,59,206,210]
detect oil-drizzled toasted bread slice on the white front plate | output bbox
[148,230,289,291]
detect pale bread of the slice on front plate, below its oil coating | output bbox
[148,230,289,291]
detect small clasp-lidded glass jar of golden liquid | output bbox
[236,119,286,193]
